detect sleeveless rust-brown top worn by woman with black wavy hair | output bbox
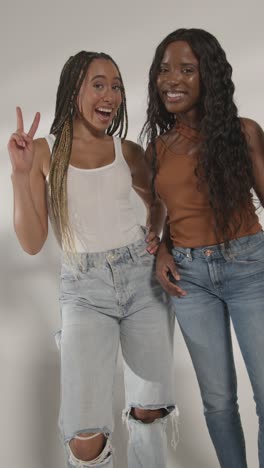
[155,123,261,248]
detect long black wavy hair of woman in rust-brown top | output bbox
[141,28,253,247]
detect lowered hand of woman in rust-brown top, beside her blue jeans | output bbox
[156,242,187,297]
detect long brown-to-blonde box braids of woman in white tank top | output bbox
[48,51,128,258]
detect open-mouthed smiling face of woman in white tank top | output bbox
[77,59,122,132]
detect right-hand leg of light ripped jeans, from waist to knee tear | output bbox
[120,252,175,409]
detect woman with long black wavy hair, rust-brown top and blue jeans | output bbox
[143,29,264,468]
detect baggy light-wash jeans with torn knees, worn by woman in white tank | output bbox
[56,240,176,468]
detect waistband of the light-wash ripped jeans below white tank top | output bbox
[62,239,147,271]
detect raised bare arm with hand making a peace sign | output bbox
[8,108,48,255]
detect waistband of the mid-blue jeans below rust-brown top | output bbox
[172,231,264,258]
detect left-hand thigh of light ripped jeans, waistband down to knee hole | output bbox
[59,271,120,441]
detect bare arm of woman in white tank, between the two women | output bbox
[123,141,166,253]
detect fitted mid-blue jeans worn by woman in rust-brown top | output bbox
[172,232,264,468]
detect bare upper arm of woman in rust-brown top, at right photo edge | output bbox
[241,119,264,207]
